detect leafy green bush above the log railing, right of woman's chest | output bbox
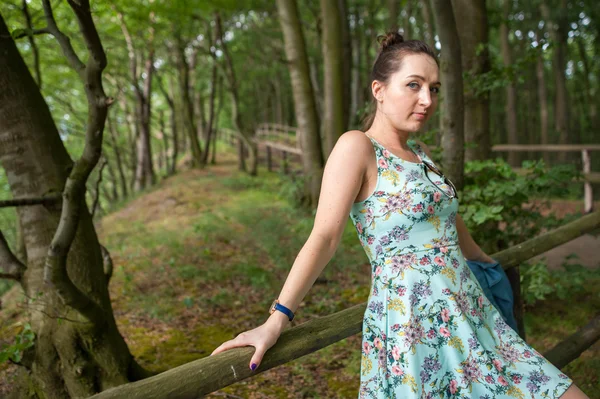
[460,159,579,253]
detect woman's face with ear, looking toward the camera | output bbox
[371,54,440,133]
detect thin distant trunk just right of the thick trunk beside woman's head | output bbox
[500,0,520,167]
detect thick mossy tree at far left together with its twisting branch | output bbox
[0,5,143,398]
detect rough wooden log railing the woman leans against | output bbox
[92,212,600,399]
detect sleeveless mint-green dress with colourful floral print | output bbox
[350,137,573,399]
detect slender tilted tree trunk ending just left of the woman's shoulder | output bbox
[277,0,323,207]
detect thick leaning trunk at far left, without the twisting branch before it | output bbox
[0,10,145,398]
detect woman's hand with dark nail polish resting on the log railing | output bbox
[210,318,285,371]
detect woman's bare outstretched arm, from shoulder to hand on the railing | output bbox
[211,131,374,370]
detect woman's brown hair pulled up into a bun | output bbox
[362,32,439,131]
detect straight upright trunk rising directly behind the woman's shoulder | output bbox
[321,0,350,159]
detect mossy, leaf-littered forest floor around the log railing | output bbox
[0,142,600,399]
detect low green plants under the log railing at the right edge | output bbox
[520,255,600,305]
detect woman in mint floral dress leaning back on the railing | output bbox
[212,33,587,399]
